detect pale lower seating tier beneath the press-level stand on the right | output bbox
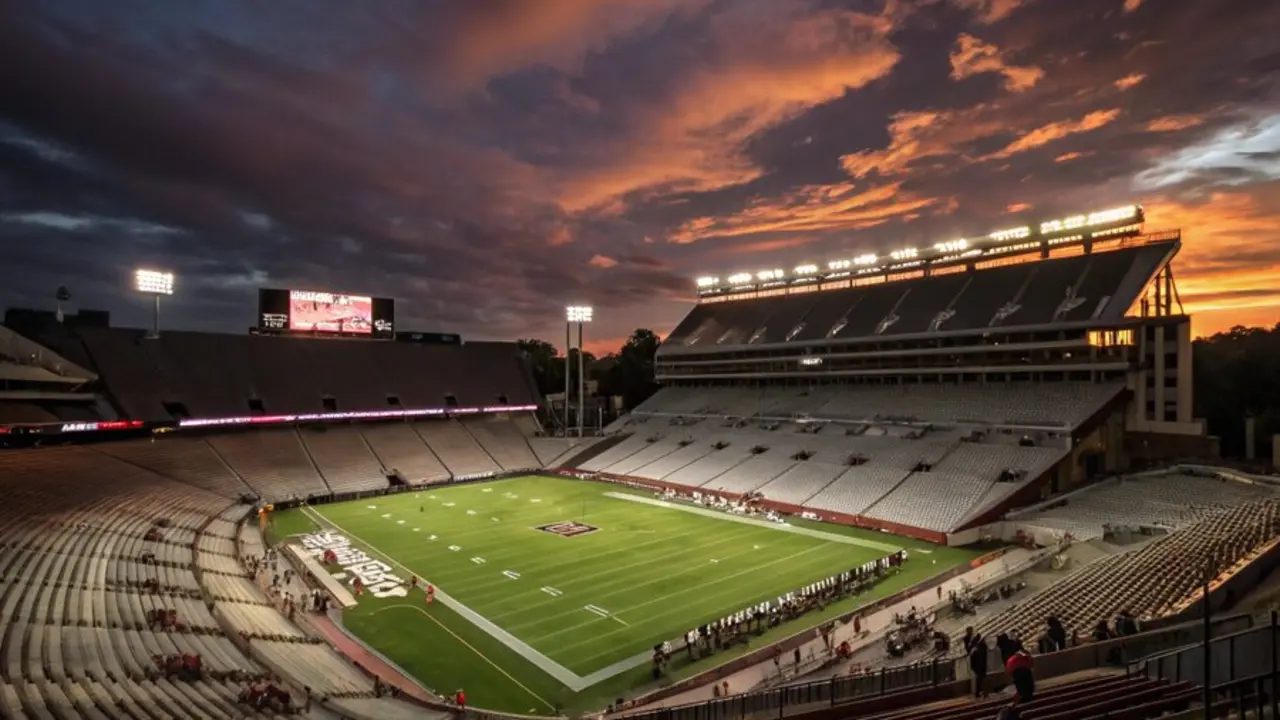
[570,383,1120,532]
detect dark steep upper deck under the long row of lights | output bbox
[663,242,1171,352]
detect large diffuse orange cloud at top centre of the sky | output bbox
[561,3,899,213]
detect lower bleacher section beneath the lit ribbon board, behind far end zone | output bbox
[95,418,541,501]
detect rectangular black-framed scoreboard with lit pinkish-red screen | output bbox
[257,288,396,340]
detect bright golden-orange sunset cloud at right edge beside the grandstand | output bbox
[1146,181,1280,334]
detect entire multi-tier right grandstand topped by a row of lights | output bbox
[586,205,1212,542]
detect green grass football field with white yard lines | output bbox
[275,477,975,714]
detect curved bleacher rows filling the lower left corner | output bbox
[0,443,443,720]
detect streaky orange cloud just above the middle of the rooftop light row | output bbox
[668,183,937,243]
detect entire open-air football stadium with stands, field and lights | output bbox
[0,205,1280,720]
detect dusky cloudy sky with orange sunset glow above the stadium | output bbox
[0,0,1280,352]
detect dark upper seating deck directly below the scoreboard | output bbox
[79,328,535,420]
